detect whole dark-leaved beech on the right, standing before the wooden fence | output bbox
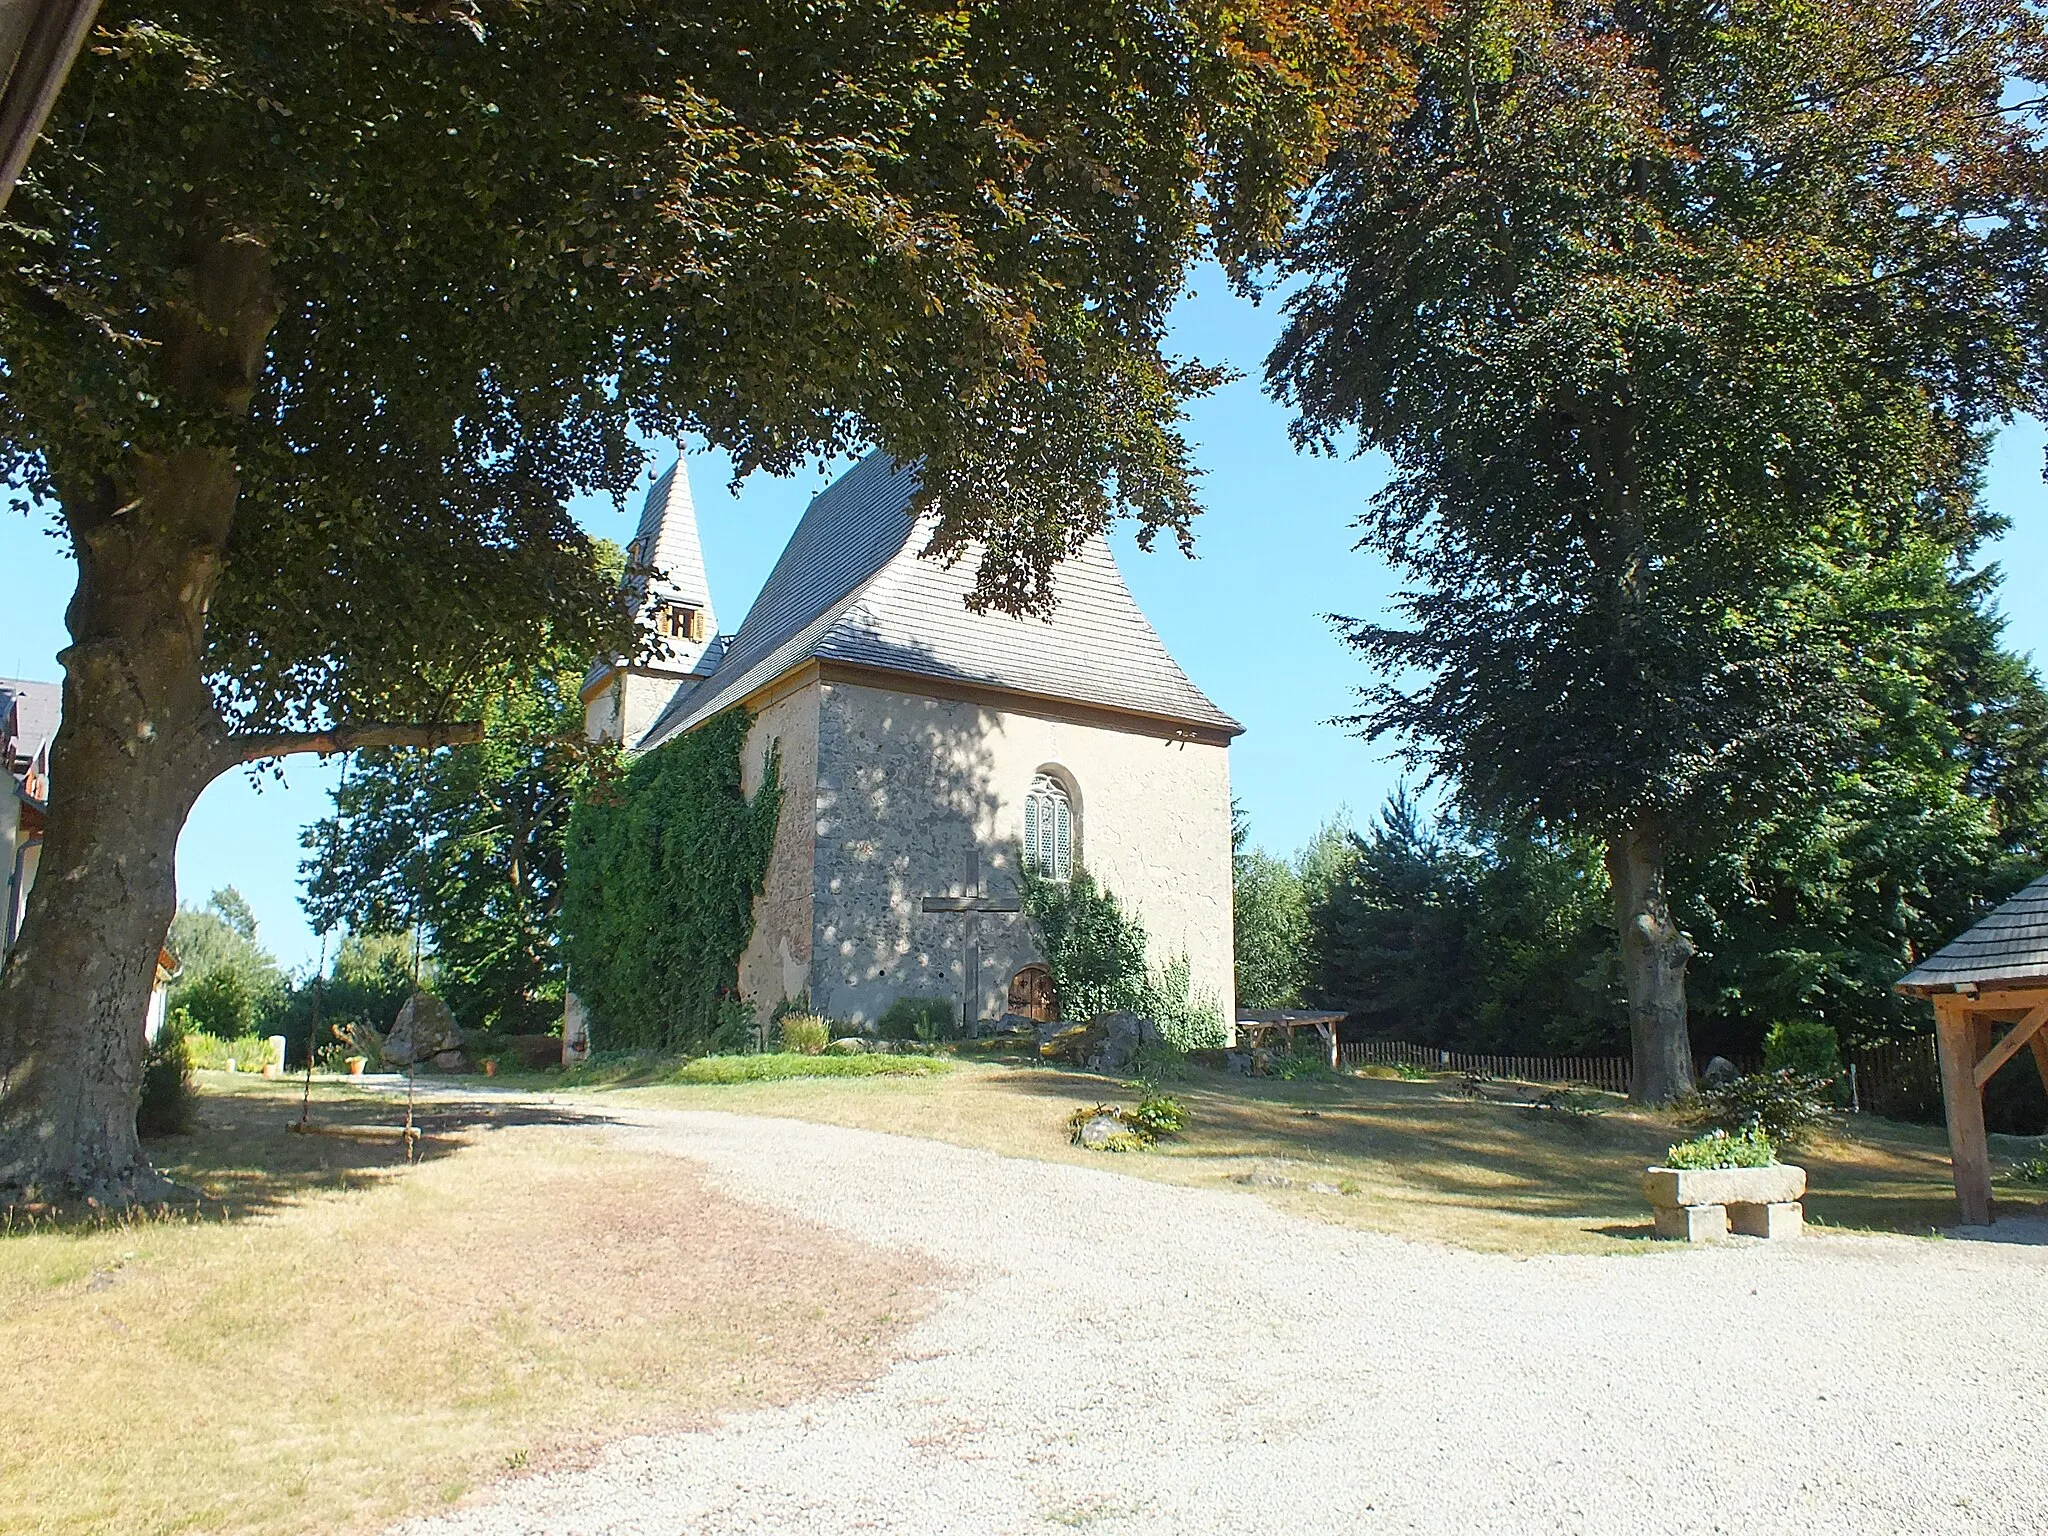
[1270,0,2048,1102]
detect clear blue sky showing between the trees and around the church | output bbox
[12,272,2048,965]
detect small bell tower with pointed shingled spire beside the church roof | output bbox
[584,459,725,752]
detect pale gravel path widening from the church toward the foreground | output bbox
[406,1112,2048,1536]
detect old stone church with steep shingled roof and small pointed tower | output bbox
[584,453,1243,1024]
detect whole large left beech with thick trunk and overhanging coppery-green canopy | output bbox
[0,0,1403,1198]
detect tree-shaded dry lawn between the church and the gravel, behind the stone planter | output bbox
[589,1063,2048,1253]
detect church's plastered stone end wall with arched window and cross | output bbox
[811,682,1233,1036]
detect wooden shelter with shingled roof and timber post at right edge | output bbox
[1898,877,2048,1227]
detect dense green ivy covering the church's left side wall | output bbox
[561,709,782,1051]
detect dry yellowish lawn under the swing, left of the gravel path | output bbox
[0,1073,932,1536]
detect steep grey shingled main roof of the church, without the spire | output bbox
[641,453,1243,748]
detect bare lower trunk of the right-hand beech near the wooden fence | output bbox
[1608,817,1694,1104]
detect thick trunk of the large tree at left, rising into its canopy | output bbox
[0,165,279,1200]
